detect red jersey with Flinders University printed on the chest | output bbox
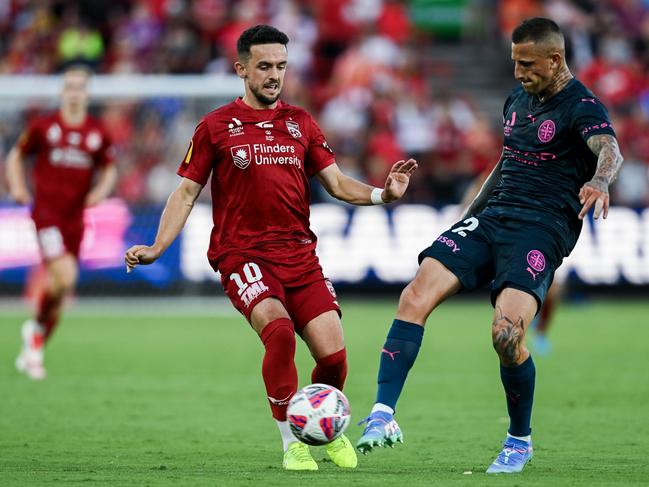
[178,99,334,271]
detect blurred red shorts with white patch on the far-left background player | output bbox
[34,218,83,261]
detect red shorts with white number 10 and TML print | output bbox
[219,256,342,333]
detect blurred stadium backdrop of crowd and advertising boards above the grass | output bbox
[0,0,649,295]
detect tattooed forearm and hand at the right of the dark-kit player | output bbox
[579,134,624,220]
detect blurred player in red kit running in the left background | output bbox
[6,66,117,379]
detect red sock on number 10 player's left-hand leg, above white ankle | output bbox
[261,318,297,421]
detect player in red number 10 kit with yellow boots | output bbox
[125,25,417,470]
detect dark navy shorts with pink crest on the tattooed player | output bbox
[419,214,563,308]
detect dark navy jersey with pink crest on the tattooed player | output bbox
[486,79,615,255]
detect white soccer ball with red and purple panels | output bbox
[286,384,351,445]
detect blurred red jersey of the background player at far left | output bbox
[18,113,114,224]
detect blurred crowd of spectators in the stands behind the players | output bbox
[0,0,649,206]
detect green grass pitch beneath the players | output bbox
[0,298,649,486]
